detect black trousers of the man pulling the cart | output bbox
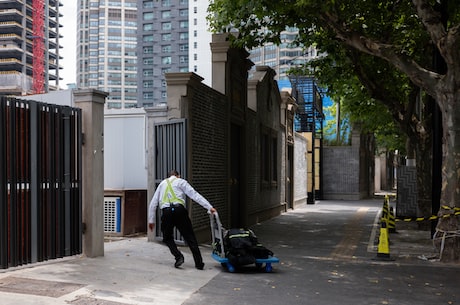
[161,205,203,266]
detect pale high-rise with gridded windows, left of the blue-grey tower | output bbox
[77,0,138,108]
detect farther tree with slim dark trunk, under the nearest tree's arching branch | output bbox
[308,44,432,229]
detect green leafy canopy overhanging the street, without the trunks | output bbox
[209,0,430,151]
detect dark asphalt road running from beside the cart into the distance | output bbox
[183,200,460,305]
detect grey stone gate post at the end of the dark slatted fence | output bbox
[73,89,108,257]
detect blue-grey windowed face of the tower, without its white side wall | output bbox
[138,0,189,107]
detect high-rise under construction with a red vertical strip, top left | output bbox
[0,0,62,95]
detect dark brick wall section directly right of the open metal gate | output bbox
[188,84,229,228]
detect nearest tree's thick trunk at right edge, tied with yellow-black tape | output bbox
[435,88,460,262]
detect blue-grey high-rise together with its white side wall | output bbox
[137,0,211,107]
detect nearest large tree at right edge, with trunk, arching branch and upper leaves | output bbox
[209,0,460,262]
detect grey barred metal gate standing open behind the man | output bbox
[153,119,187,243]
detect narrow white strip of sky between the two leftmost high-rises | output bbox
[59,0,78,89]
